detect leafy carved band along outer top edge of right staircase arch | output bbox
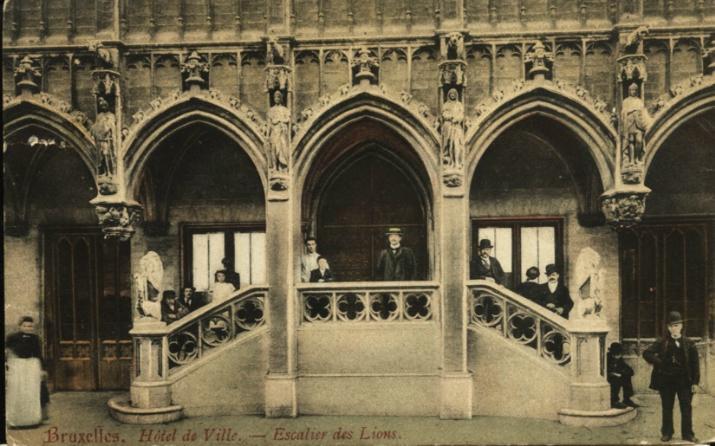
[468,80,613,131]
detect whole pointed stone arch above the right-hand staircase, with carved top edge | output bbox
[466,81,617,190]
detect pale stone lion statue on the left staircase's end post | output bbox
[134,251,164,321]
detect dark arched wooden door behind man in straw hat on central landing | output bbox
[317,154,429,281]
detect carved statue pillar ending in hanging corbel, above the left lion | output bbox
[89,42,142,240]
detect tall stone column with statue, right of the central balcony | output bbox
[440,32,473,418]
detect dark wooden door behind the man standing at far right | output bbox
[619,221,708,339]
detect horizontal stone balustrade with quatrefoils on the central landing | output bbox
[296,281,440,324]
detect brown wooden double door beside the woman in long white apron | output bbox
[44,229,132,390]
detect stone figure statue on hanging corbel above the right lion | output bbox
[621,82,651,168]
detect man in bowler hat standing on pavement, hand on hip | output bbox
[643,311,700,443]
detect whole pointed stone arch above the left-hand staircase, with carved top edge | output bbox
[122,90,267,196]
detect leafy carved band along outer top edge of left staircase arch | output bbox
[122,89,266,145]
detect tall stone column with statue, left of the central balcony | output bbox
[265,39,298,417]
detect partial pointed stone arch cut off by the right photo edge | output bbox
[644,75,715,173]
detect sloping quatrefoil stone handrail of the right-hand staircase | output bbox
[467,280,575,366]
